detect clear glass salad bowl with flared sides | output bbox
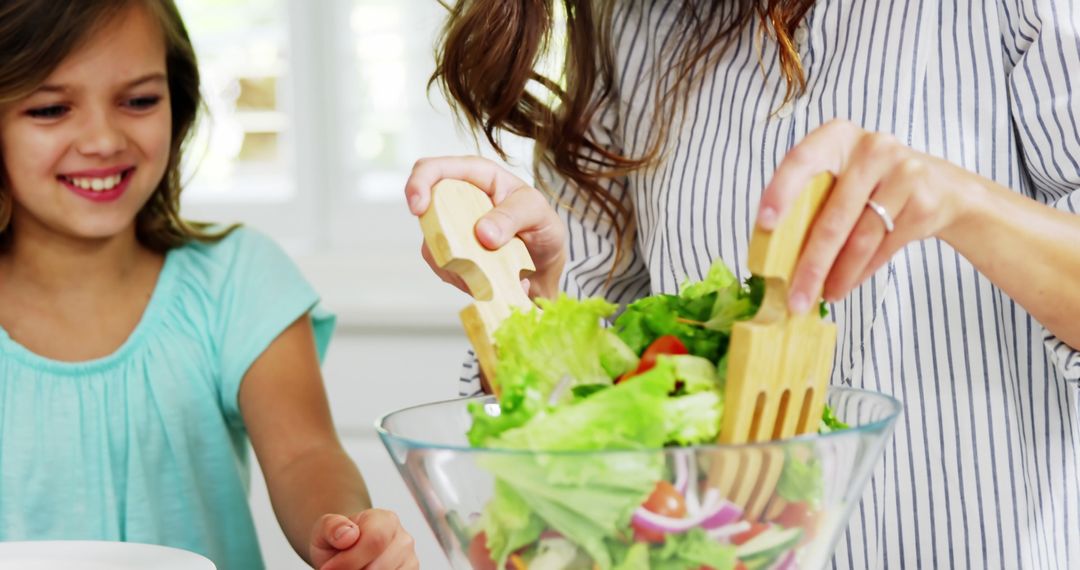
[377,388,902,570]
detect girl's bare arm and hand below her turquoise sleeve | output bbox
[240,315,418,569]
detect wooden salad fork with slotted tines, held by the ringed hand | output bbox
[711,173,836,520]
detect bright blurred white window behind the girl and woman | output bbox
[177,0,540,257]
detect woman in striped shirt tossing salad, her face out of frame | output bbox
[405,0,1080,569]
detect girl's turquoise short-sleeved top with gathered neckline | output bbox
[0,229,334,570]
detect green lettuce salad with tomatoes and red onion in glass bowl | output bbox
[461,262,847,570]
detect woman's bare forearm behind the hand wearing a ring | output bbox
[940,166,1080,349]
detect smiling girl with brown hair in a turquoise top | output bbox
[0,0,417,569]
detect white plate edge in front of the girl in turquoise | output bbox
[0,541,215,570]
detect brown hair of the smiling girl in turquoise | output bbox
[0,0,229,252]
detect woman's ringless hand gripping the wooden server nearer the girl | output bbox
[405,157,566,298]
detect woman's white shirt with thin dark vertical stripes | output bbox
[461,0,1080,569]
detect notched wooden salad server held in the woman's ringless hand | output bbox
[420,180,536,396]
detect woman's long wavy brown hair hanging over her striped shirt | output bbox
[431,0,814,253]
